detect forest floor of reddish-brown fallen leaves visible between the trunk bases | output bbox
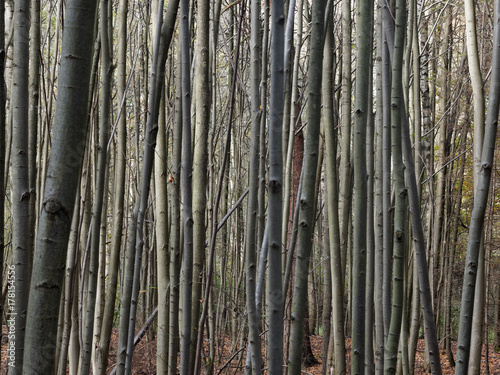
[0,326,500,375]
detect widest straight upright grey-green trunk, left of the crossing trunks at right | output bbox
[351,0,373,374]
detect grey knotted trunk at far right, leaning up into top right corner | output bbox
[455,0,500,374]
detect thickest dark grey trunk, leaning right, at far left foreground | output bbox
[23,0,97,374]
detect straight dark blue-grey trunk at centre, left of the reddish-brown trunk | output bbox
[267,0,285,375]
